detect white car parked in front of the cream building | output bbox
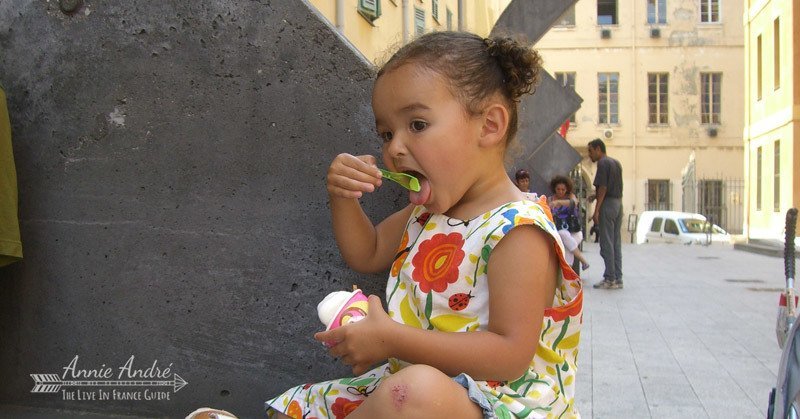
[636,211,731,244]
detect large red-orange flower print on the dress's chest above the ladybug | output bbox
[411,233,464,293]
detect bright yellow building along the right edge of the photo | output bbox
[743,0,800,240]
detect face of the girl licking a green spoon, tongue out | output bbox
[372,64,487,213]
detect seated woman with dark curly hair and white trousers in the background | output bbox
[547,176,589,270]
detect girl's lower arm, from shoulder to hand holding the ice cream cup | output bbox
[315,226,558,381]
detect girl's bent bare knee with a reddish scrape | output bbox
[348,365,483,419]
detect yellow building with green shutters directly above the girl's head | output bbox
[308,0,511,64]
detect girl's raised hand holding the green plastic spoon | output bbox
[328,153,382,198]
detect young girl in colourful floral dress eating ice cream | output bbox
[266,32,582,418]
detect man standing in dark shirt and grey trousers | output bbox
[589,138,622,289]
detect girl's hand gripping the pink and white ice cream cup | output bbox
[314,295,399,375]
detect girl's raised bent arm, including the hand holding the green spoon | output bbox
[328,154,413,273]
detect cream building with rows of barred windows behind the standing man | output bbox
[536,0,744,237]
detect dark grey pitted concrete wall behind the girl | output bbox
[0,0,574,417]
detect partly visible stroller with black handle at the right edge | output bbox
[767,208,800,419]
